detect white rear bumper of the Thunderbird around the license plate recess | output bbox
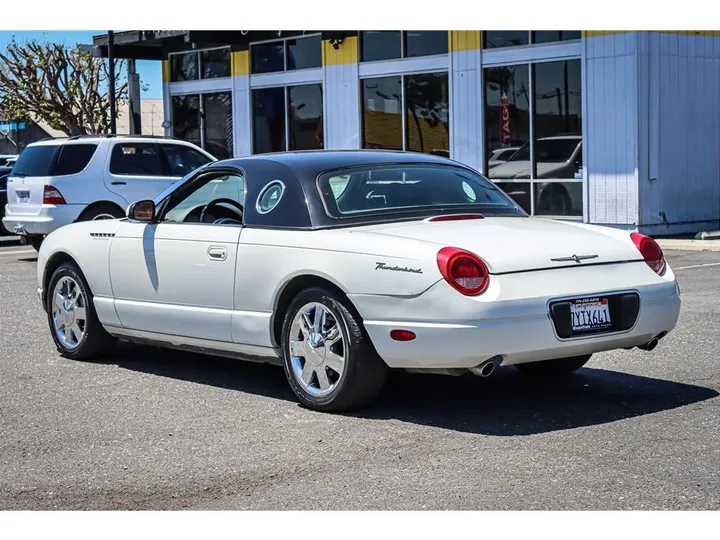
[358,282,681,369]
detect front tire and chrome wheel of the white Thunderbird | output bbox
[46,262,116,360]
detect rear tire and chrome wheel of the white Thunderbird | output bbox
[282,288,388,411]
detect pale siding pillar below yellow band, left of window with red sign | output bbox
[450,49,484,171]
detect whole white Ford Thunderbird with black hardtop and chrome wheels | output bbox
[37,151,680,410]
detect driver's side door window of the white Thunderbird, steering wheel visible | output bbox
[163,174,245,223]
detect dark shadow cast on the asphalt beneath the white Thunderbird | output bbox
[105,345,720,436]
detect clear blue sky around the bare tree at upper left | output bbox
[0,30,163,99]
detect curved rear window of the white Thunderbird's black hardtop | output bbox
[318,165,525,218]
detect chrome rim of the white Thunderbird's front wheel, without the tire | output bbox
[52,276,87,350]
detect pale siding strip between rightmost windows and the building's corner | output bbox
[582,33,638,225]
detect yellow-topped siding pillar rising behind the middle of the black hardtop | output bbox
[323,36,362,149]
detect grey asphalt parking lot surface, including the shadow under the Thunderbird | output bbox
[0,236,720,510]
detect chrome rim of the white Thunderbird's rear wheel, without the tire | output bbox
[288,302,346,397]
